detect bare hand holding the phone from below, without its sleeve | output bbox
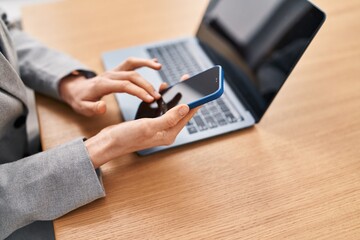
[85,104,197,168]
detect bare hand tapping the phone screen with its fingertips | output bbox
[59,58,161,116]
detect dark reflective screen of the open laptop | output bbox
[197,0,325,122]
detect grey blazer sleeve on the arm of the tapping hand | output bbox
[10,28,96,99]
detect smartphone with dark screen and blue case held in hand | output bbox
[135,66,224,119]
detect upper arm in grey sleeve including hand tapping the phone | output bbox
[10,28,161,116]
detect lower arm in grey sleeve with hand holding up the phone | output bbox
[0,84,196,239]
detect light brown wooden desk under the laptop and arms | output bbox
[23,0,360,239]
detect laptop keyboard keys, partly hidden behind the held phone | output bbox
[147,42,244,134]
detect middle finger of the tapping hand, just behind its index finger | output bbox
[106,71,161,99]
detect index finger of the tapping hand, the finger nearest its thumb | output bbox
[97,79,155,102]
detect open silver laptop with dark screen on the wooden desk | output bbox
[102,0,325,155]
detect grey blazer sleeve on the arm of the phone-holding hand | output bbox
[0,139,105,239]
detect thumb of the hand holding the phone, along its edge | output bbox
[154,104,190,130]
